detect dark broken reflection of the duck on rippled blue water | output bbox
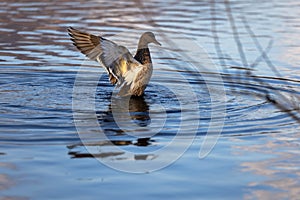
[68,96,155,160]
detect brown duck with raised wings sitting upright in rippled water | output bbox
[67,27,161,97]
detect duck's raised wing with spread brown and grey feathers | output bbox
[68,27,142,85]
